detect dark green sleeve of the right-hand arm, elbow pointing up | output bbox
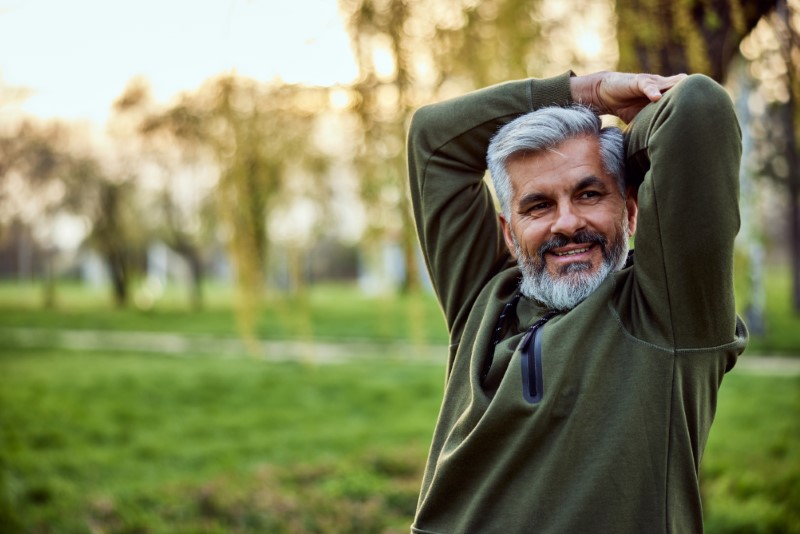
[626,75,741,349]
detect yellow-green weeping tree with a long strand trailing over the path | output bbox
[139,75,328,333]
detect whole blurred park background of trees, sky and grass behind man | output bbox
[0,0,800,532]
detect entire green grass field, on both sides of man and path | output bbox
[0,278,800,533]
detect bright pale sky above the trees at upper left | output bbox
[0,0,357,124]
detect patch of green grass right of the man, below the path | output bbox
[702,371,800,534]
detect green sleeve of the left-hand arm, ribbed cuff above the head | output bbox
[408,72,570,339]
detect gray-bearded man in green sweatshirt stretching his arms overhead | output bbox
[409,73,746,534]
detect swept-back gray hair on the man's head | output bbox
[486,104,625,219]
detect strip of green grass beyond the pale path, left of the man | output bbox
[0,282,447,343]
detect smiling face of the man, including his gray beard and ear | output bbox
[501,137,637,310]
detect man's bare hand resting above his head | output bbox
[570,72,686,122]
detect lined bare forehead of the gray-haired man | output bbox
[506,137,616,198]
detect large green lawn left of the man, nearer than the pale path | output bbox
[0,350,443,532]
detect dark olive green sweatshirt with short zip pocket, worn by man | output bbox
[408,74,747,534]
